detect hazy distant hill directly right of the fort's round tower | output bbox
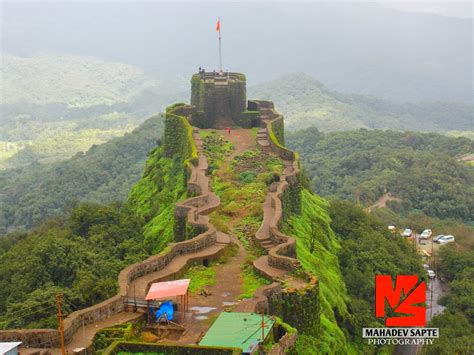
[249,73,474,132]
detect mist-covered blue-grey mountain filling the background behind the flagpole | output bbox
[2,2,473,102]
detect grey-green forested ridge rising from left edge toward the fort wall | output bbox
[0,116,163,233]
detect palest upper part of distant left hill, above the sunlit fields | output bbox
[1,53,159,108]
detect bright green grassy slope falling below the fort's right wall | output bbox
[284,190,351,354]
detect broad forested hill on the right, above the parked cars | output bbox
[287,128,474,222]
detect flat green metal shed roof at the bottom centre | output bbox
[199,312,275,354]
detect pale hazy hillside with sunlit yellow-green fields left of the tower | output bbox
[0,54,186,170]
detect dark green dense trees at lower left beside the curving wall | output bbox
[0,203,147,329]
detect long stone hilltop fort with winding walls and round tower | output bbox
[0,70,336,354]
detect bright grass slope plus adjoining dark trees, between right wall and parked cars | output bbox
[284,190,425,354]
